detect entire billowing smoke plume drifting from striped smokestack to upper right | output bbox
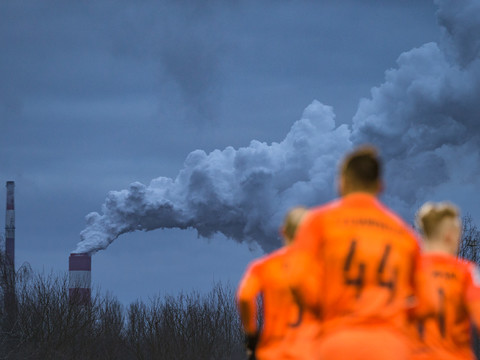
[75,0,480,253]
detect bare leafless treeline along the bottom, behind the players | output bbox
[0,216,480,360]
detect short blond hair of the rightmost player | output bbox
[416,202,459,241]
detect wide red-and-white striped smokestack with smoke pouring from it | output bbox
[68,253,92,304]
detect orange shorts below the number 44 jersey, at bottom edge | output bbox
[317,326,410,360]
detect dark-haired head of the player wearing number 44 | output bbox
[340,145,382,195]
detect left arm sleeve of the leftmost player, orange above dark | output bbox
[237,264,261,334]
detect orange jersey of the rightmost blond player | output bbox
[414,253,480,360]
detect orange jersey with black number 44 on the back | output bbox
[290,193,420,358]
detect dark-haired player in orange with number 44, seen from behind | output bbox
[290,147,419,360]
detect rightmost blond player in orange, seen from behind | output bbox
[414,203,480,360]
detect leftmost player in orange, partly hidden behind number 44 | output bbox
[237,208,319,360]
